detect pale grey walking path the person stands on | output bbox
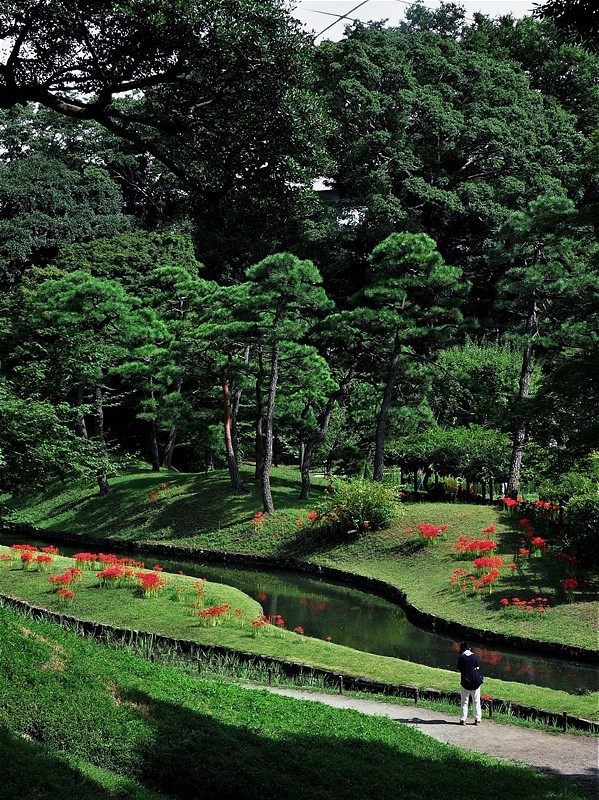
[247,686,599,799]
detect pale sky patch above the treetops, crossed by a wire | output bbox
[294,0,540,42]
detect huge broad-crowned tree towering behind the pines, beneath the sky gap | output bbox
[316,13,584,306]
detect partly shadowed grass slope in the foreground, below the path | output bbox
[0,608,588,800]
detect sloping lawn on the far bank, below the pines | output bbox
[5,467,599,649]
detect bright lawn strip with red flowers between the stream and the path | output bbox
[0,546,599,719]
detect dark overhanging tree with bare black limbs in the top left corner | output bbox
[0,0,324,197]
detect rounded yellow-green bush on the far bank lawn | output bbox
[308,479,400,534]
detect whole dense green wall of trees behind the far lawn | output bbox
[0,0,599,521]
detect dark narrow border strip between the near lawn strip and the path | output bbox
[0,594,599,734]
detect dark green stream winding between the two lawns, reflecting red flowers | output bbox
[0,535,599,694]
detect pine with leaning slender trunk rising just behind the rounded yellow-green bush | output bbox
[355,233,461,481]
